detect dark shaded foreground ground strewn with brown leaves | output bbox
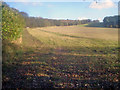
[3,46,120,89]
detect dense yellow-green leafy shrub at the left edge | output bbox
[2,3,24,41]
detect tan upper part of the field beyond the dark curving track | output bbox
[41,26,118,41]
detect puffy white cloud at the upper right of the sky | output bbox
[89,0,116,9]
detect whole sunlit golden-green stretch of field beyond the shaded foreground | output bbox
[28,26,118,47]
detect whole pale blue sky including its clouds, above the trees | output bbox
[7,0,118,21]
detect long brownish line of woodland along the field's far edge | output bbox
[20,12,99,27]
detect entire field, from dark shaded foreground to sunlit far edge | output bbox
[4,26,120,88]
